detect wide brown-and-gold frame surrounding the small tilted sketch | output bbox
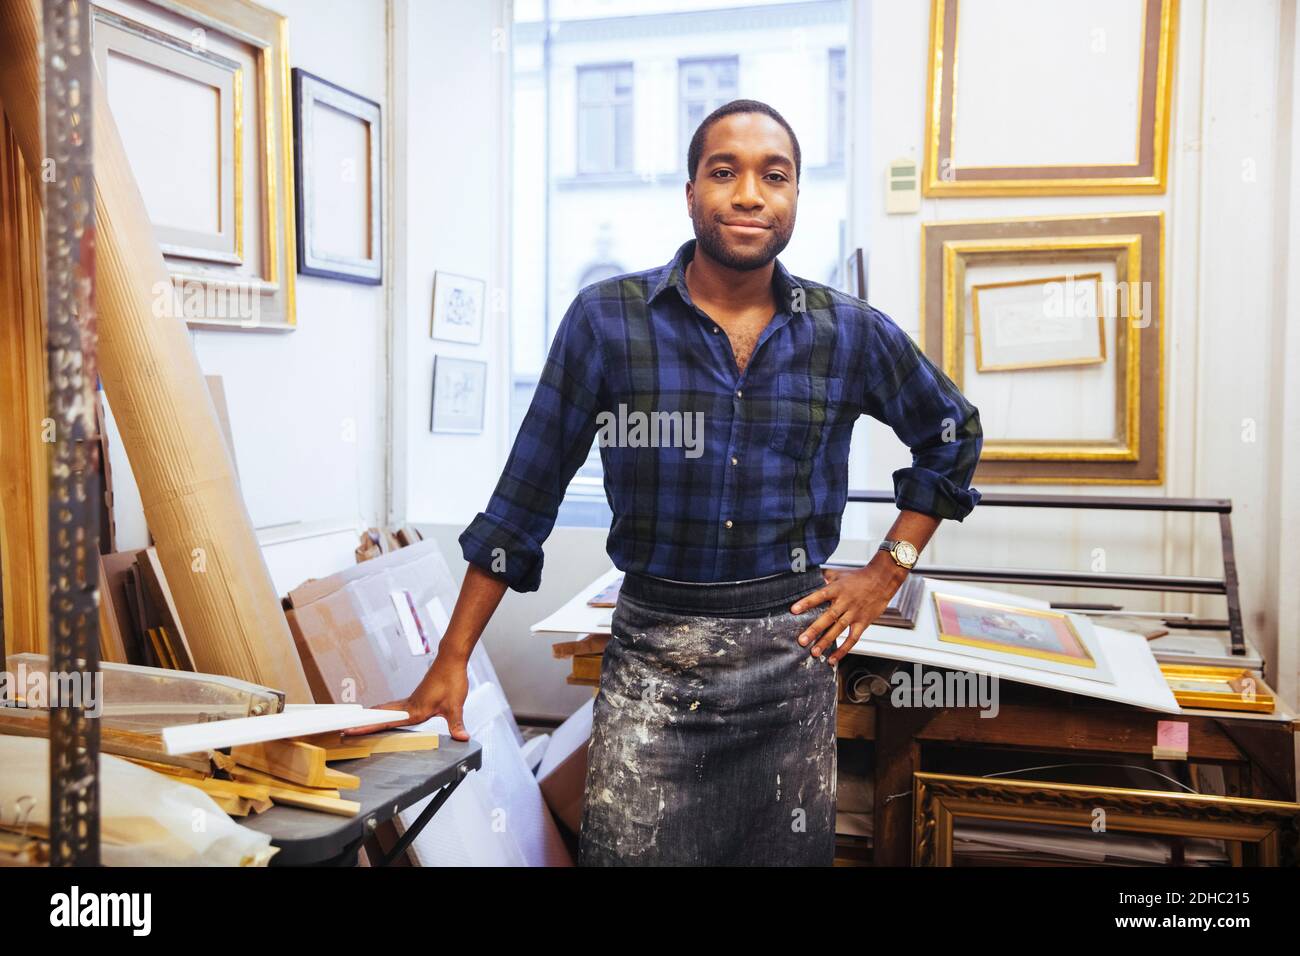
[920,212,1164,484]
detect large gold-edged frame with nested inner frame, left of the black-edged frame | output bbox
[92,0,296,332]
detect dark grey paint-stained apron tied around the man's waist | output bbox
[579,568,836,866]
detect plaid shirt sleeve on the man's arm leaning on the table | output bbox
[459,294,605,592]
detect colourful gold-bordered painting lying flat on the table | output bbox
[933,591,1097,669]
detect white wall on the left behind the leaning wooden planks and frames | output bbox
[109,0,391,592]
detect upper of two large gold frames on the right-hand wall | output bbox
[922,0,1178,196]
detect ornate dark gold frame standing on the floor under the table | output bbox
[911,773,1300,866]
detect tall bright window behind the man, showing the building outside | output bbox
[510,0,850,527]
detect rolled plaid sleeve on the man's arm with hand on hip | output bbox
[863,308,984,522]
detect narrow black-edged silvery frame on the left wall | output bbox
[294,69,384,285]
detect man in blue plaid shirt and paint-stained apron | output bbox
[351,100,982,865]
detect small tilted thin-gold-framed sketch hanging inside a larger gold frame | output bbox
[971,272,1106,372]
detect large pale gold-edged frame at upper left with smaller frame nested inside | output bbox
[92,0,298,332]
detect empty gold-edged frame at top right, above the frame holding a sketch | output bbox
[922,0,1178,196]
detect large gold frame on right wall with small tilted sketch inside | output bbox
[920,212,1164,484]
